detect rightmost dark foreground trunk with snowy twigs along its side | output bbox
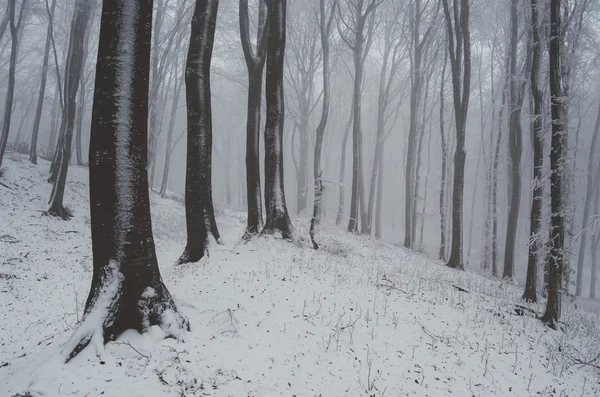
[542,0,567,327]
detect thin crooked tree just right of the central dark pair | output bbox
[310,0,338,249]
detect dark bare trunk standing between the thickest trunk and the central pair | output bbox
[178,0,224,264]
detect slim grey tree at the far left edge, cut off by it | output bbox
[0,0,27,167]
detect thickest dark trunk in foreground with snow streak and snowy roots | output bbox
[65,0,189,361]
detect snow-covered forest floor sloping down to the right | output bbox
[0,153,600,397]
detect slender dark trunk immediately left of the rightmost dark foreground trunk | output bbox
[523,0,544,302]
